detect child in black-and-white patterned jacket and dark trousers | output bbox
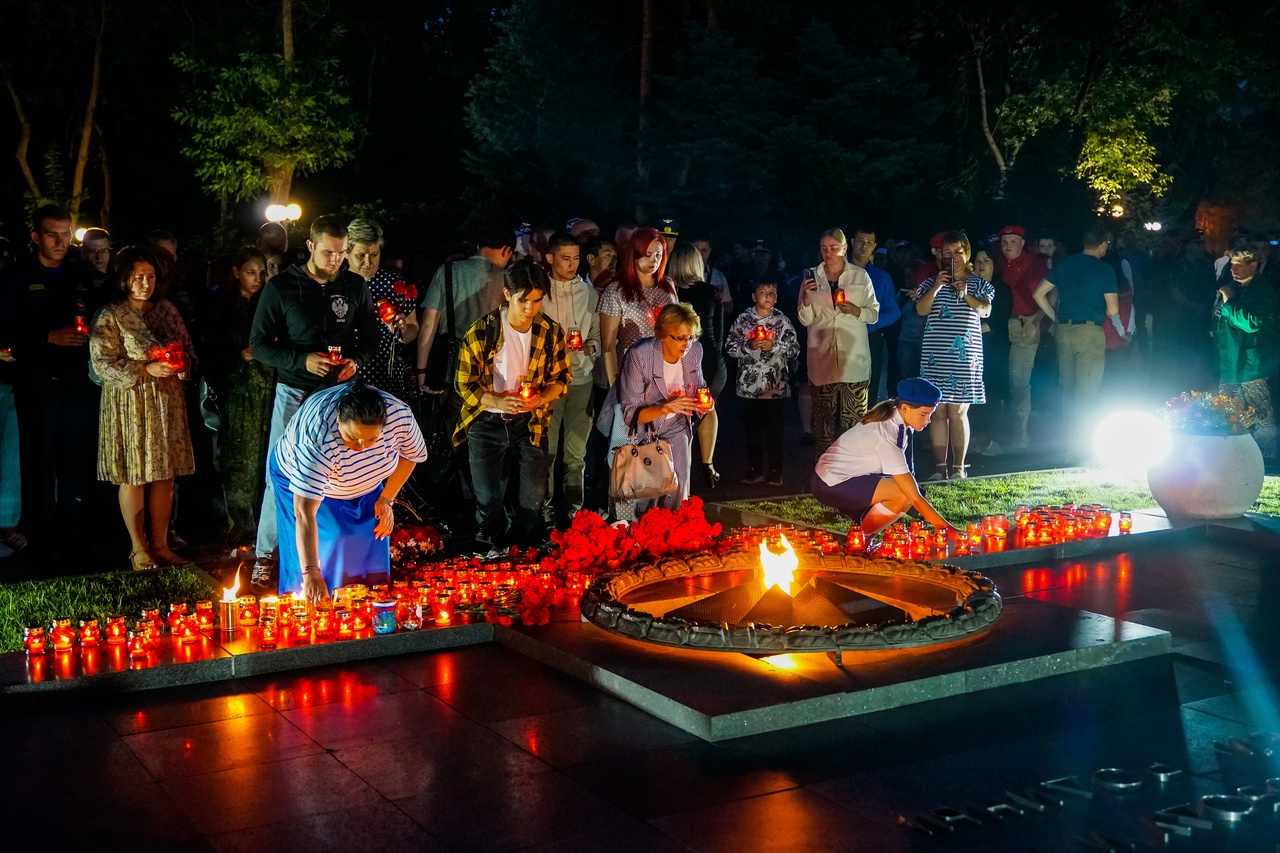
[724,282,800,485]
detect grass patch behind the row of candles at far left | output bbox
[0,566,218,652]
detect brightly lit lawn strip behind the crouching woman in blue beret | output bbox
[731,470,1280,533]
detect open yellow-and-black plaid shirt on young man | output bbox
[453,309,573,447]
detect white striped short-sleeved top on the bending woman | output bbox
[275,384,426,501]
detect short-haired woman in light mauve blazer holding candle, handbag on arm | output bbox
[599,302,712,517]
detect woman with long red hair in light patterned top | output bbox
[599,228,678,386]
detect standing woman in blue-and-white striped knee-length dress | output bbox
[915,231,996,480]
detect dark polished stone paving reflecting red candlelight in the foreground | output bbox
[0,540,1280,852]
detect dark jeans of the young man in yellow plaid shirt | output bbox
[467,411,547,547]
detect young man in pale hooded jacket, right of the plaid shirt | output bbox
[543,232,600,524]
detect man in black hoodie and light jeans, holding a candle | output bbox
[248,216,378,588]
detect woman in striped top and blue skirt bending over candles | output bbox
[266,374,426,603]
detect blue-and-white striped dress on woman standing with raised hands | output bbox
[915,274,996,403]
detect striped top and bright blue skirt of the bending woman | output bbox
[268,384,426,594]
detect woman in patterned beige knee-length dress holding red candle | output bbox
[90,246,196,569]
